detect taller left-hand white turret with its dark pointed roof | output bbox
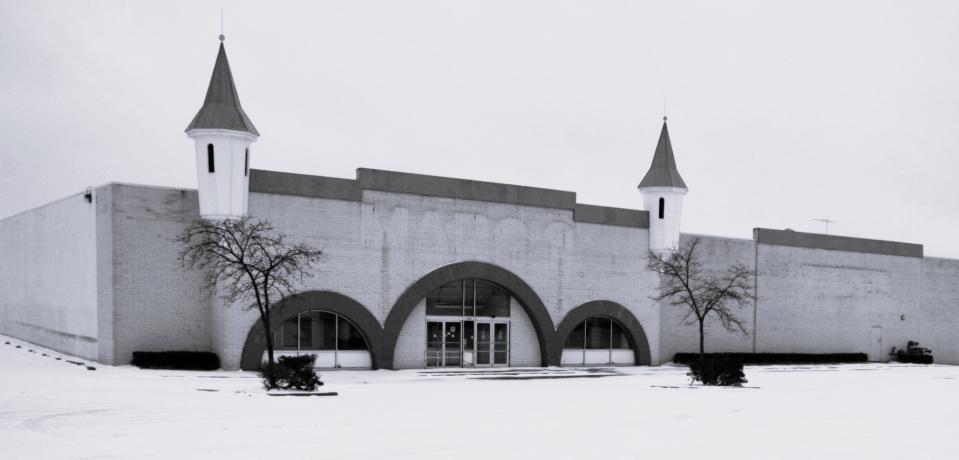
[186,35,260,219]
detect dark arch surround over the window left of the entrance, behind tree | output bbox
[240,291,383,371]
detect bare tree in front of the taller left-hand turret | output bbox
[176,217,322,388]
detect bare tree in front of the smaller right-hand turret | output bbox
[647,238,756,362]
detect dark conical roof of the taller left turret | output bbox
[186,41,260,136]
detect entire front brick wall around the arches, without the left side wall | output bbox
[92,185,959,368]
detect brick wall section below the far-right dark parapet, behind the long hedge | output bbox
[756,244,922,360]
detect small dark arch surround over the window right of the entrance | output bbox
[549,300,651,366]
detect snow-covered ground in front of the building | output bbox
[0,336,959,460]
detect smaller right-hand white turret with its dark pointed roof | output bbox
[639,117,688,255]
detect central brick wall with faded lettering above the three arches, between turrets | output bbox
[212,190,659,366]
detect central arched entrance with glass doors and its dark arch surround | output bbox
[379,261,554,368]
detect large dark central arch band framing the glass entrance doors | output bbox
[377,261,559,369]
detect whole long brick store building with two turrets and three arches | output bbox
[0,37,959,369]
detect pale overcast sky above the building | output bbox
[0,0,959,258]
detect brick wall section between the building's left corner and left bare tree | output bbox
[108,184,215,364]
